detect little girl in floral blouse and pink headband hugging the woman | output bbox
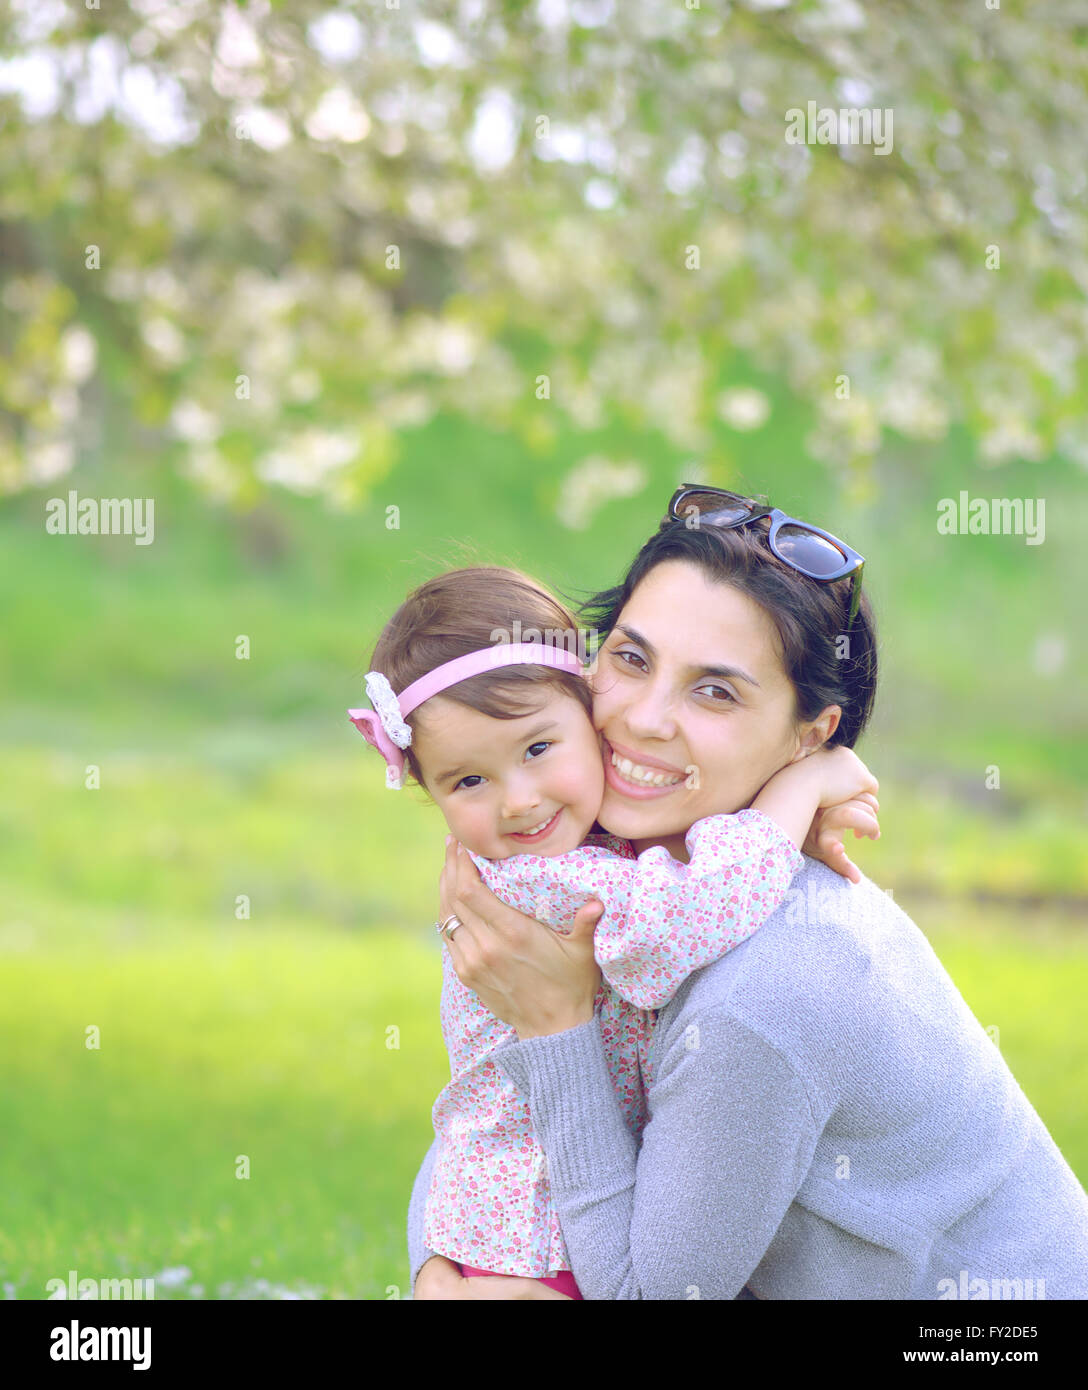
[347,567,875,1298]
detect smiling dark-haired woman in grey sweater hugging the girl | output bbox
[409,489,1088,1298]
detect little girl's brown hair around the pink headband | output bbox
[367,564,593,787]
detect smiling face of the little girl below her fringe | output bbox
[413,687,604,859]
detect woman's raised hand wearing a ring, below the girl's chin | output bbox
[439,835,604,1039]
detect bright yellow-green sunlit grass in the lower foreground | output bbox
[0,889,1088,1298]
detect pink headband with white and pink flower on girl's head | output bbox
[347,642,585,791]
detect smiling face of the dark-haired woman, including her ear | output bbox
[592,560,838,860]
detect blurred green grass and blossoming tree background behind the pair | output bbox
[0,0,1088,1298]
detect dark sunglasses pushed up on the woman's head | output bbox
[668,482,866,630]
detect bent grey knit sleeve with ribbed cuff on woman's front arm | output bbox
[493,1005,818,1300]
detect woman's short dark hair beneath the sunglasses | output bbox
[578,517,877,748]
